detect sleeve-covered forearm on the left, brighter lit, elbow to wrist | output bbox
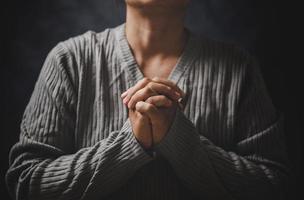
[7,121,151,199]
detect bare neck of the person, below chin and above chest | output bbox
[126,6,186,64]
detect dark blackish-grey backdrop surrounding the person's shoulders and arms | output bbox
[0,0,304,199]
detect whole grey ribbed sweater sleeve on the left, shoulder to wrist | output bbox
[6,44,152,200]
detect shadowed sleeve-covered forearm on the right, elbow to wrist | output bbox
[155,111,287,199]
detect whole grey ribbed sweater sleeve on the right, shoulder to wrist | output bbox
[155,55,289,199]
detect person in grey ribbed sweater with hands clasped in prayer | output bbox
[6,0,289,200]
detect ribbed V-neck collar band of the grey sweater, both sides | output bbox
[114,23,198,84]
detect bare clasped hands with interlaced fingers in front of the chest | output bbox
[121,77,185,149]
